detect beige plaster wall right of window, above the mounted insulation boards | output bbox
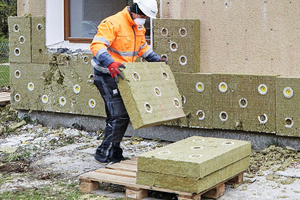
[161,0,300,77]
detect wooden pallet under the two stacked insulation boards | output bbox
[79,159,243,200]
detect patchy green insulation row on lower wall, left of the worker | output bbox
[10,63,106,116]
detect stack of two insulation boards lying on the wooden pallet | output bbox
[136,136,251,193]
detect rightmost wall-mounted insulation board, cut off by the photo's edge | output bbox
[276,77,300,137]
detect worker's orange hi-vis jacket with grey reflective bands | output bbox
[90,7,153,64]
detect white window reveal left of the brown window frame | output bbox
[46,0,64,46]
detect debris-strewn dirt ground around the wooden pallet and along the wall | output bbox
[0,106,300,200]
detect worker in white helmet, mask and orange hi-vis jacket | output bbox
[90,0,166,165]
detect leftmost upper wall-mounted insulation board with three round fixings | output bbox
[8,17,31,63]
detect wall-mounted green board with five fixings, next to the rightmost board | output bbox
[212,74,276,133]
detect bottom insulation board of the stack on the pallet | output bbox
[136,156,250,193]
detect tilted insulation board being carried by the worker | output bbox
[118,62,185,129]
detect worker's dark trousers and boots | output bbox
[94,74,129,162]
